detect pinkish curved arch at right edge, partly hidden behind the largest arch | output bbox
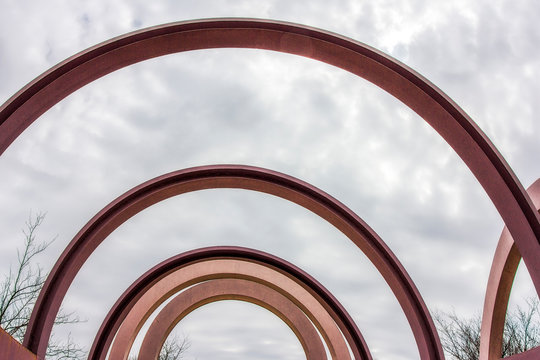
[480,179,540,360]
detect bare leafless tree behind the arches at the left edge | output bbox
[0,213,85,360]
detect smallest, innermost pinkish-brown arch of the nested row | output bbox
[138,279,326,360]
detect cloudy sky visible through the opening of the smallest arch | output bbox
[161,300,306,360]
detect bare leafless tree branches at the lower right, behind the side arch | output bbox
[435,299,540,360]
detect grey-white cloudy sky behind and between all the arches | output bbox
[0,0,540,360]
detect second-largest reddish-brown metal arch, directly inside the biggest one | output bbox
[24,165,438,359]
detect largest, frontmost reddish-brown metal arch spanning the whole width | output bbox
[0,18,540,294]
